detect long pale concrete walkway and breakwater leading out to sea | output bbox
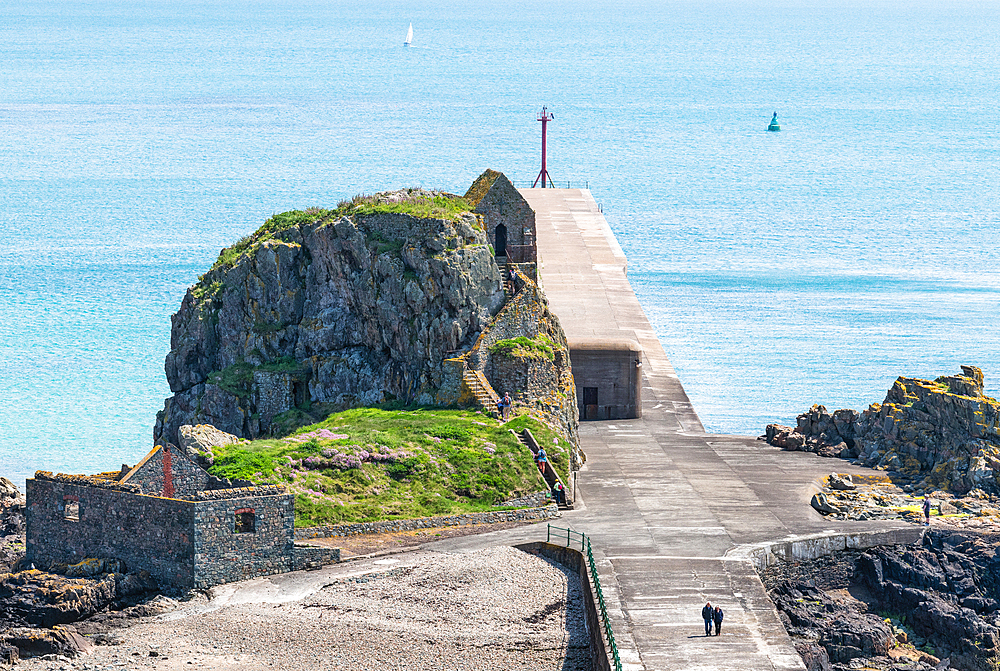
[428,189,919,671]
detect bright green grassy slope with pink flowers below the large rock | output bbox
[209,406,570,526]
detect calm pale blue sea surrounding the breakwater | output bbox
[0,0,1000,485]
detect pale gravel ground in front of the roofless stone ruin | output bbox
[16,546,590,671]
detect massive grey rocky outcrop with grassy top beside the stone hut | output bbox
[154,190,504,443]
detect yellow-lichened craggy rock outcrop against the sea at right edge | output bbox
[763,366,1000,494]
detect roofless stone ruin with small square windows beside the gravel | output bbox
[26,445,339,589]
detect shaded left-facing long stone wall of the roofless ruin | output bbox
[26,474,195,588]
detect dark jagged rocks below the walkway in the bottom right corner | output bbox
[761,530,1000,671]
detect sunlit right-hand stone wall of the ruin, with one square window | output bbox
[194,494,295,587]
